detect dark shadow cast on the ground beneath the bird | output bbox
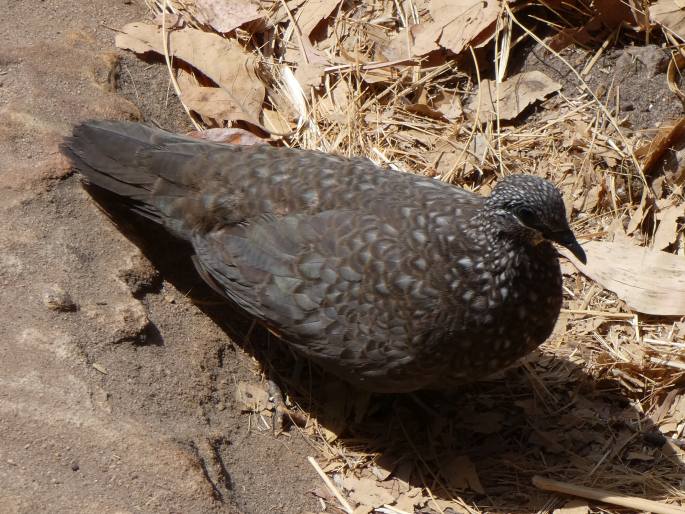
[81,183,665,512]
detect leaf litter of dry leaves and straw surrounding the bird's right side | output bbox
[121,0,685,514]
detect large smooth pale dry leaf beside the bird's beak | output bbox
[560,241,685,316]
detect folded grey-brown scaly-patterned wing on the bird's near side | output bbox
[192,210,440,376]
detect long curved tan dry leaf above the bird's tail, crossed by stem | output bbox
[116,23,265,125]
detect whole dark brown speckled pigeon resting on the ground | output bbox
[61,121,586,393]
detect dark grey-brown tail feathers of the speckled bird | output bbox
[60,121,199,237]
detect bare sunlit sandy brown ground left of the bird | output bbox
[0,0,318,513]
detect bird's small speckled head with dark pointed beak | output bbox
[486,175,586,264]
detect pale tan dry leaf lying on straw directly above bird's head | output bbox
[464,71,561,122]
